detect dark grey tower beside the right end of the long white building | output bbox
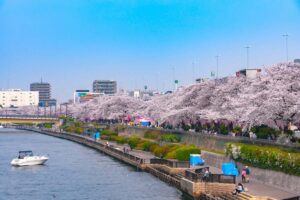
[30,82,56,106]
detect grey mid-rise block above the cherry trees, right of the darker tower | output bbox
[93,80,117,95]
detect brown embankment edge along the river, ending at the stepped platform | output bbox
[17,129,300,198]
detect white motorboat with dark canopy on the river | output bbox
[10,151,49,166]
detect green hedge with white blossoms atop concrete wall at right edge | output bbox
[226,143,300,176]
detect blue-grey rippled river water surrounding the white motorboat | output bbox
[0,129,188,200]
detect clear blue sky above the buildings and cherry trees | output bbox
[0,0,300,101]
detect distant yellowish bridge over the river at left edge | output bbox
[0,115,60,124]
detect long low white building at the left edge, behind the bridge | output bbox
[0,89,39,107]
